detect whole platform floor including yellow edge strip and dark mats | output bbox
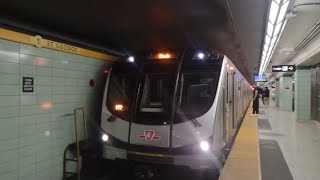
[219,102,320,180]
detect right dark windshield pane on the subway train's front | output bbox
[176,72,218,122]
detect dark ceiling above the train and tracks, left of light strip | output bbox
[0,0,269,81]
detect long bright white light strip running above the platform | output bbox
[259,0,290,75]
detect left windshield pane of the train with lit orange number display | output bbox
[107,62,138,120]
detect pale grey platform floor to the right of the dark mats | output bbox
[258,101,320,180]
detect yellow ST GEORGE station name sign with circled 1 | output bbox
[30,35,80,54]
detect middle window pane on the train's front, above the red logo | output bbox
[136,64,177,124]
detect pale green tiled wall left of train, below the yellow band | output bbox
[0,40,110,180]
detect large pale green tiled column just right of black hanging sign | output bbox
[295,69,311,120]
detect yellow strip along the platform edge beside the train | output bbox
[219,102,261,180]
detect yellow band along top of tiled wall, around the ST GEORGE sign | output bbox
[0,28,118,61]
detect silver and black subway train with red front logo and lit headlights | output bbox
[101,48,252,176]
